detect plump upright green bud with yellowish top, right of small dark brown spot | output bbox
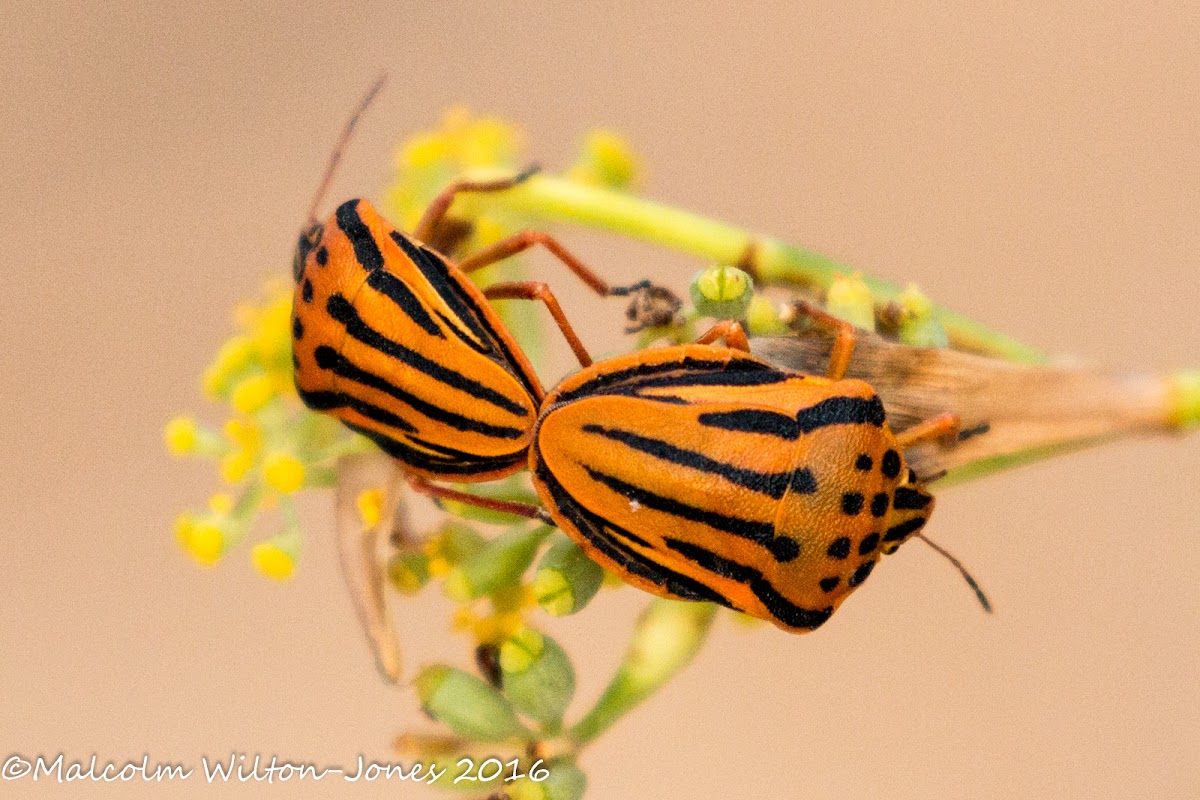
[500,628,575,726]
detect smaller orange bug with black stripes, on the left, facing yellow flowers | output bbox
[292,84,667,482]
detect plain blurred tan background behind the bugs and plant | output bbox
[0,0,1200,799]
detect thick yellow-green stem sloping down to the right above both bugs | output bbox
[472,175,1045,363]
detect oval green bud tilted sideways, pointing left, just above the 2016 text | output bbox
[414,664,529,742]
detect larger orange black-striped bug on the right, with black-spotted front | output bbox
[520,307,970,632]
